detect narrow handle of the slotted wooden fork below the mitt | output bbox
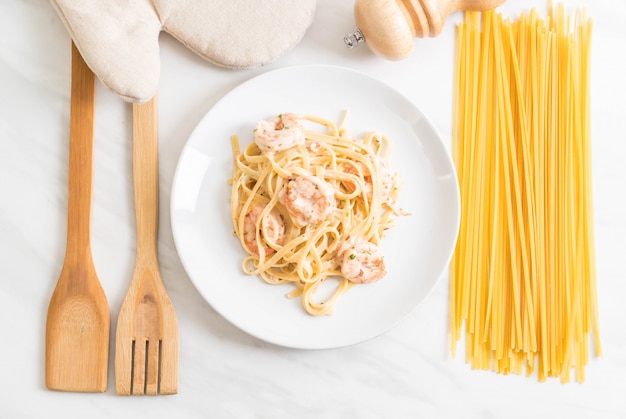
[133,94,159,263]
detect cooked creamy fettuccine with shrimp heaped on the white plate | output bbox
[231,113,406,316]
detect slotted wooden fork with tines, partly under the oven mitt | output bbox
[115,95,178,395]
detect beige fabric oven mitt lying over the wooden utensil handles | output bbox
[51,0,316,102]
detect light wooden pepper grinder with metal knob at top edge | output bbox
[344,0,505,60]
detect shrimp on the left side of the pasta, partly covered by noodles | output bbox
[243,203,285,256]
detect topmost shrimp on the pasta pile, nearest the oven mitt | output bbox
[254,113,305,153]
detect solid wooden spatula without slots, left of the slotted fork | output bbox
[46,43,110,392]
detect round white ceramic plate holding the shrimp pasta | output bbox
[171,65,459,349]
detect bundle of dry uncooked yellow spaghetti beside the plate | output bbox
[450,5,601,382]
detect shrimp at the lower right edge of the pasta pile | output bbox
[337,237,387,284]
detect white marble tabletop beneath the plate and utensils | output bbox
[0,0,626,419]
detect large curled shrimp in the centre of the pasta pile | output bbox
[278,176,336,227]
